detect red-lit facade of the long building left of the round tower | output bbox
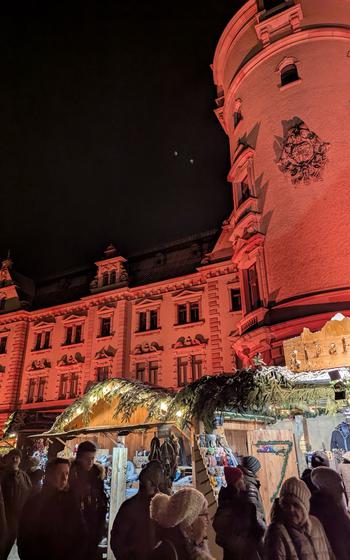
[0,259,241,434]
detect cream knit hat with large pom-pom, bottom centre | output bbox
[151,488,208,528]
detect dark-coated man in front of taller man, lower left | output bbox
[17,458,87,560]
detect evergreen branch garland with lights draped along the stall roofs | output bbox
[50,366,350,433]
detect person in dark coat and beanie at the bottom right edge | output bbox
[310,467,350,560]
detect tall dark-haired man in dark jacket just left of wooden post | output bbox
[69,441,107,560]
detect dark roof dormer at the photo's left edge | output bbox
[0,255,34,314]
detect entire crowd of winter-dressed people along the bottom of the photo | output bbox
[0,441,350,560]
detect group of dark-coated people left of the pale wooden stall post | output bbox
[0,441,107,560]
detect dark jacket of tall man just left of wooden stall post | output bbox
[69,461,107,546]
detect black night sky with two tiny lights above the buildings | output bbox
[0,0,240,278]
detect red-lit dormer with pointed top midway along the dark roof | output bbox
[90,244,128,294]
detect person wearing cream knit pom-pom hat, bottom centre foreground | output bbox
[150,488,214,560]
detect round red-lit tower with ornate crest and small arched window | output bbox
[213,0,350,363]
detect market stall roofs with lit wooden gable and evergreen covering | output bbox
[30,366,350,437]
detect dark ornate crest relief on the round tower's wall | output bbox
[278,123,329,184]
